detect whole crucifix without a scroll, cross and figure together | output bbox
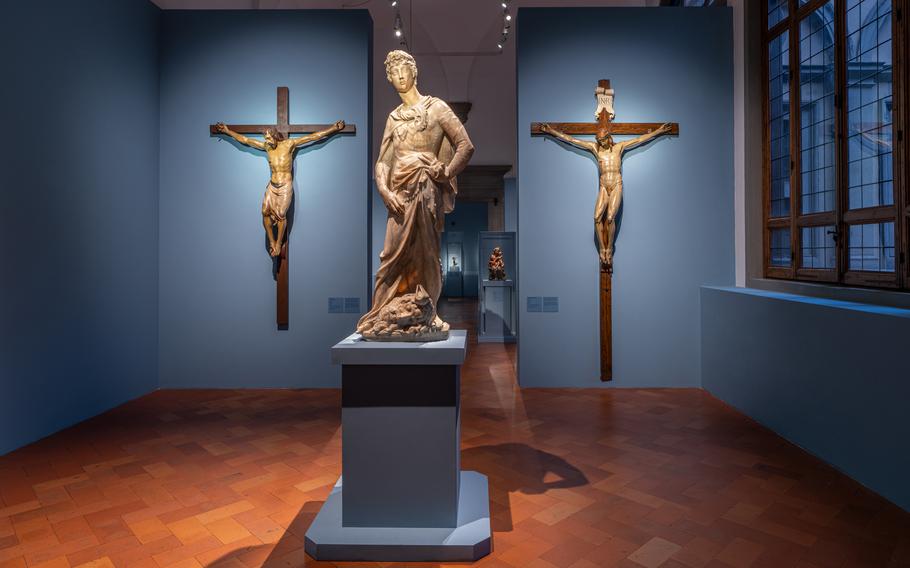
[209,87,356,329]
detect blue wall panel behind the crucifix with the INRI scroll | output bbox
[517,8,734,387]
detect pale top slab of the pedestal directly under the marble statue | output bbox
[332,329,468,365]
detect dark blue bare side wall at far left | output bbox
[0,0,160,454]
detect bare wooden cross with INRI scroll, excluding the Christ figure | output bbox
[531,79,679,381]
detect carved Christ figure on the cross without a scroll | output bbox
[215,120,344,257]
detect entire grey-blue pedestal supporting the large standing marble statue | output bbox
[306,331,491,562]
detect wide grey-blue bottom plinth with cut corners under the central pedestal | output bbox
[306,471,492,562]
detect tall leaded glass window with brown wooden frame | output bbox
[763,0,910,289]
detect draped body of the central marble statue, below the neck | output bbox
[357,96,473,332]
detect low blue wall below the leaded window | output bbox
[701,288,910,510]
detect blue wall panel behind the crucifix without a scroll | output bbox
[160,10,372,388]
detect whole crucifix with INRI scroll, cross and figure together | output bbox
[531,79,679,381]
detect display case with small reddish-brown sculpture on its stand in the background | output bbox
[477,231,517,343]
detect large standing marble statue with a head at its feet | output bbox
[357,50,474,341]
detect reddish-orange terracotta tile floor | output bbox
[0,302,910,568]
